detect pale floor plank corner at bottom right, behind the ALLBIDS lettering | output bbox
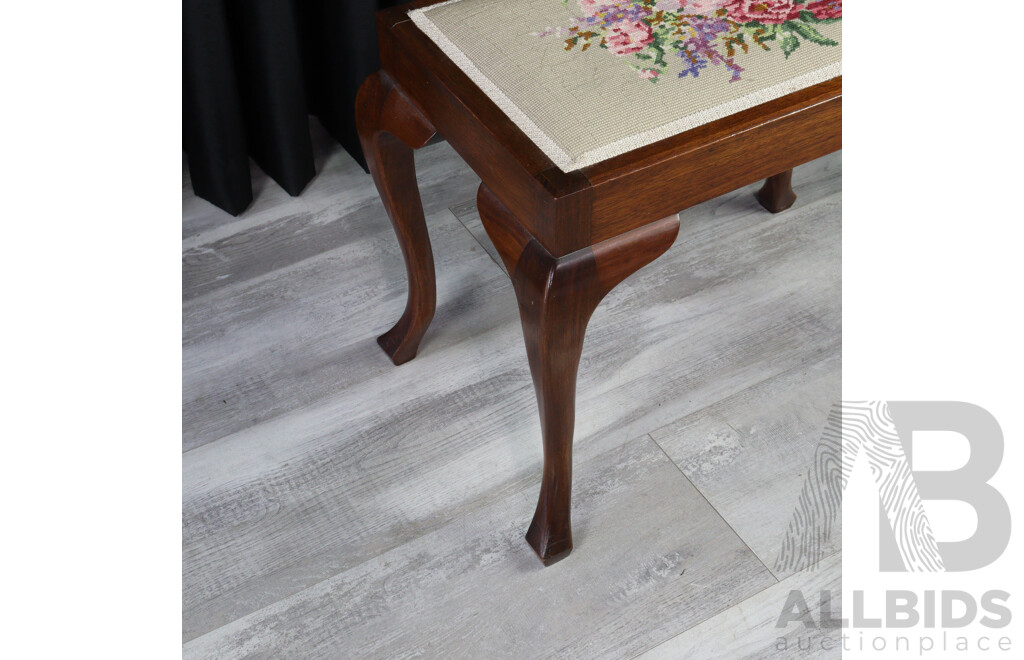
[639,553,843,660]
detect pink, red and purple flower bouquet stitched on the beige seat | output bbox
[535,0,843,83]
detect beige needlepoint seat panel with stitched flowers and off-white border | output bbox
[410,0,843,172]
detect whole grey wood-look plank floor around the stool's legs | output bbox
[182,120,842,658]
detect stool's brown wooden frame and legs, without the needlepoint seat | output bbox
[359,0,842,564]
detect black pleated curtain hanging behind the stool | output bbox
[182,0,404,215]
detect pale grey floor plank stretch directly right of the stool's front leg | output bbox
[552,181,841,458]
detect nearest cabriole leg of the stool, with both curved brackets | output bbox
[476,184,679,564]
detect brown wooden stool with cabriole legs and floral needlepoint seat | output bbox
[356,0,842,564]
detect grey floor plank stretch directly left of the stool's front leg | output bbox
[182,276,540,639]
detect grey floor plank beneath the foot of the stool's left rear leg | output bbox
[182,204,514,451]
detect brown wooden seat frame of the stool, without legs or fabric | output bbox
[378,2,843,257]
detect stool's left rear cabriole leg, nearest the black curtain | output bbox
[355,72,436,364]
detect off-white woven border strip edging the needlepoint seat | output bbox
[409,0,843,172]
